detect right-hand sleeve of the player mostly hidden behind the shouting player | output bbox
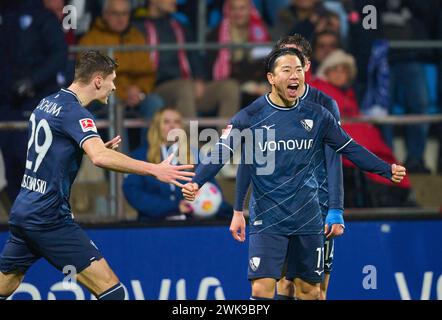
[324,98,344,210]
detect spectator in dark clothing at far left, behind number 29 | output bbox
[0,0,67,200]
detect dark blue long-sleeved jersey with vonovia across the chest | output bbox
[193,95,391,235]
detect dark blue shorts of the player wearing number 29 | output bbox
[0,221,103,273]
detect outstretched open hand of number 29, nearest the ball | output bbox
[153,153,195,188]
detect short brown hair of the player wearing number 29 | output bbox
[74,50,118,83]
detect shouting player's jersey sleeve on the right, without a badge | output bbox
[324,112,392,179]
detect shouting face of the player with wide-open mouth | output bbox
[267,54,305,107]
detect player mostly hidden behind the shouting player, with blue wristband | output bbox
[237,34,344,300]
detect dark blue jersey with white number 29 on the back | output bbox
[9,89,99,229]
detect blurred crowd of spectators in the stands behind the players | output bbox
[0,0,442,220]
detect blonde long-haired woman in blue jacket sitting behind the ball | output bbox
[123,107,232,220]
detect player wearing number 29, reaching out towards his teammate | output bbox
[0,51,194,300]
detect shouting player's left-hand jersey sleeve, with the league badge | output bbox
[193,111,248,187]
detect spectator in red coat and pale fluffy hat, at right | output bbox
[311,49,412,207]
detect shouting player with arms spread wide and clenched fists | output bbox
[182,48,406,299]
